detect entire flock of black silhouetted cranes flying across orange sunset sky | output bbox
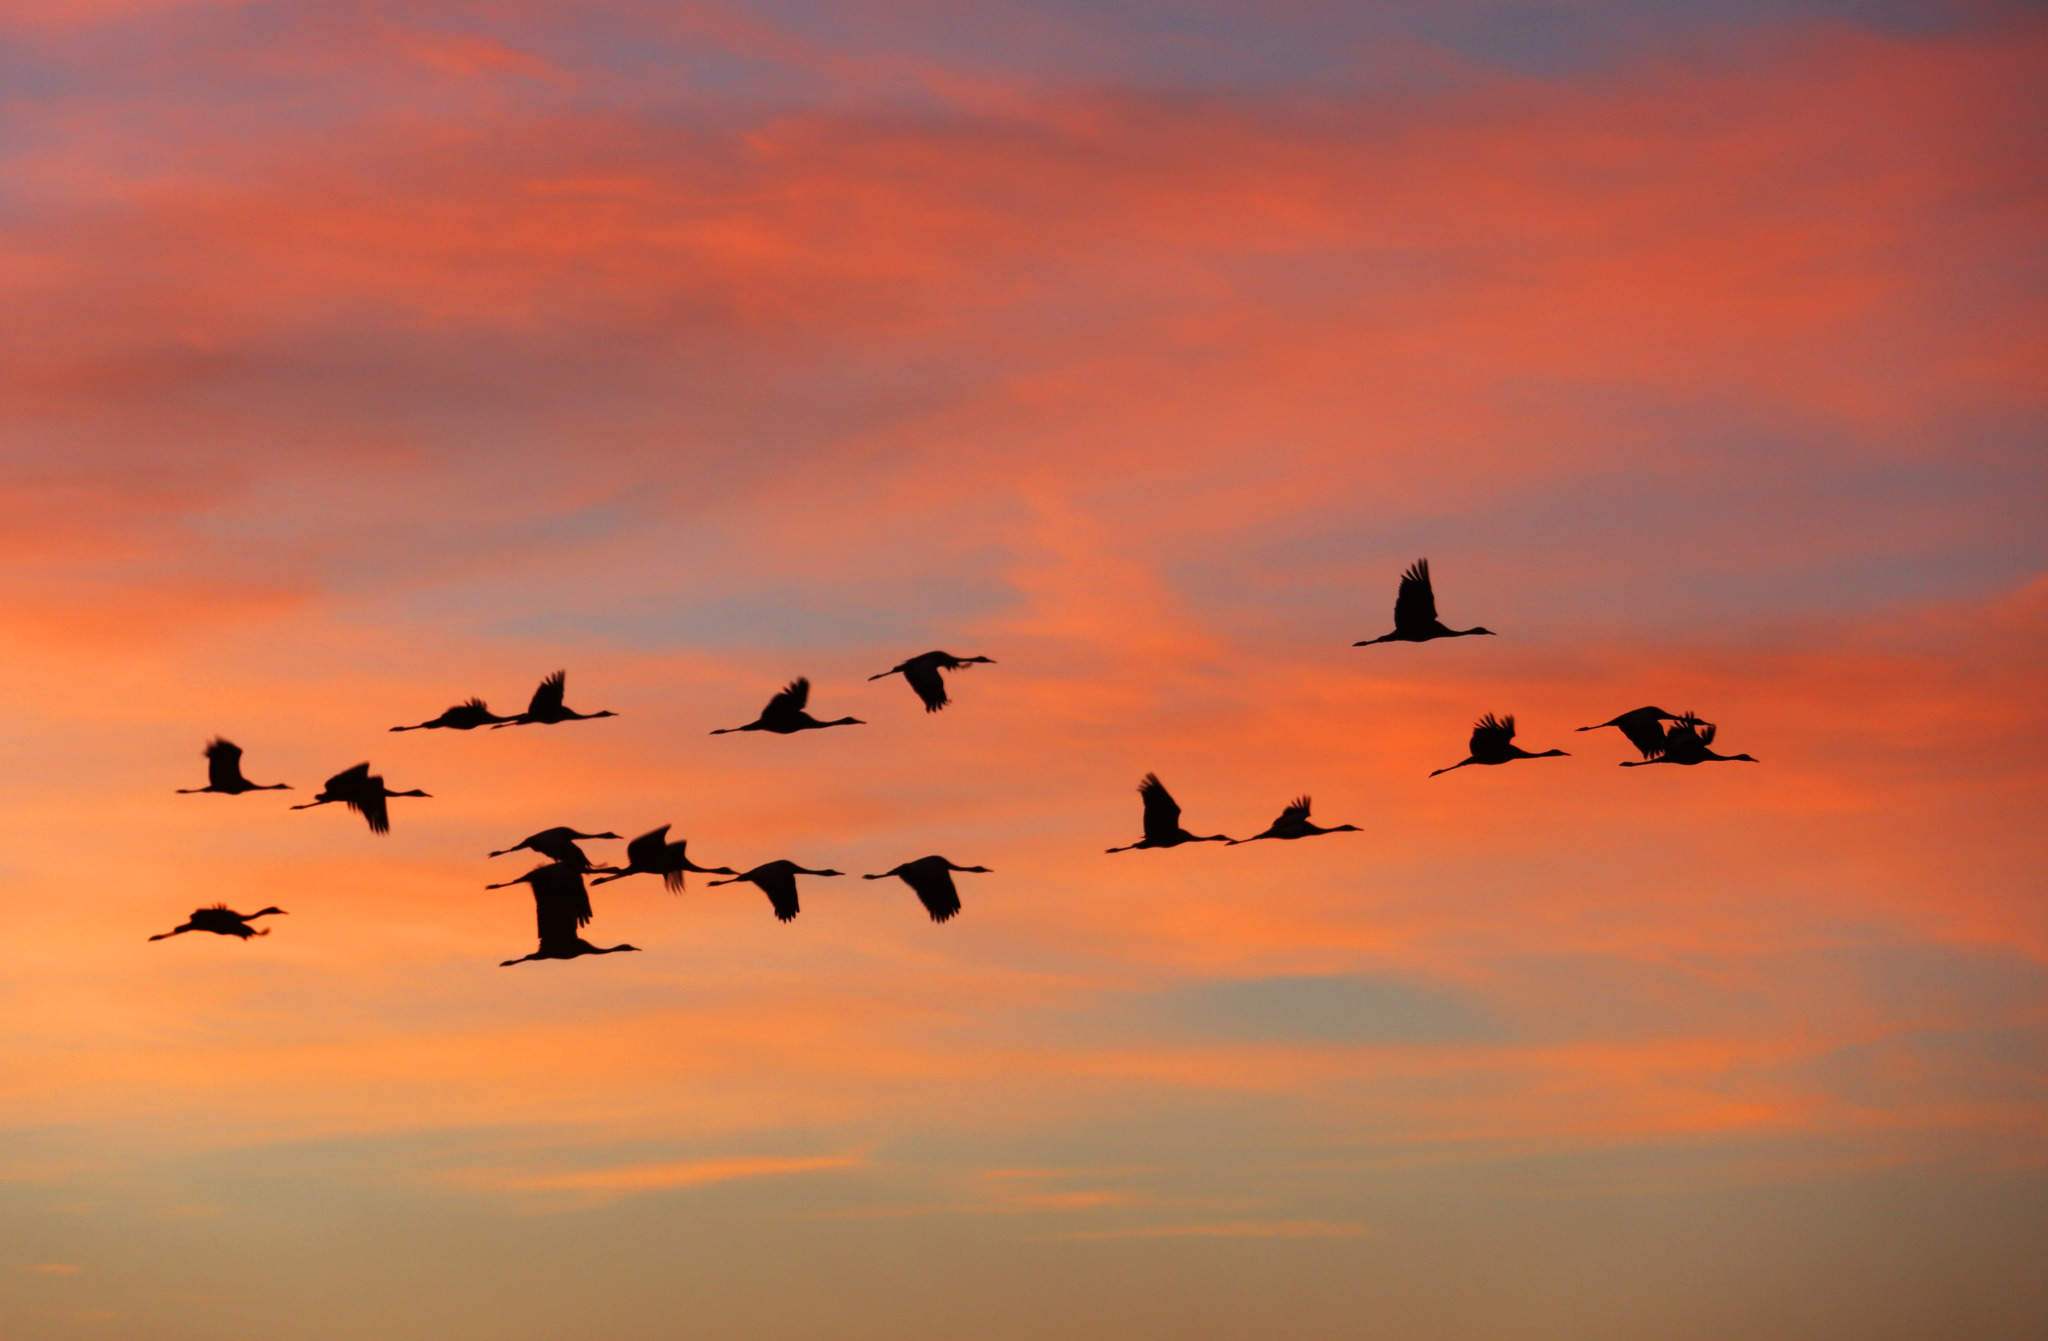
[150,559,1755,966]
